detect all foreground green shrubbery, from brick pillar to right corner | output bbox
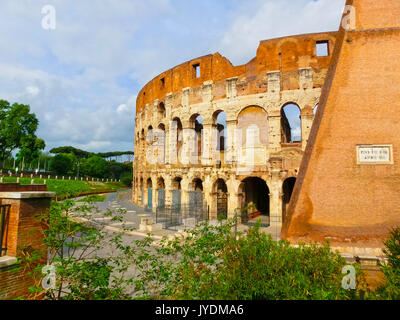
[19,205,400,300]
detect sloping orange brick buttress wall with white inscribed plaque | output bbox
[282,0,400,255]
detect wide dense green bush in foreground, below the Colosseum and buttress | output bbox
[133,220,355,300]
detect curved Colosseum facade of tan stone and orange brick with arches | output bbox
[132,32,337,230]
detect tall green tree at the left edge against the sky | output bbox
[0,100,43,164]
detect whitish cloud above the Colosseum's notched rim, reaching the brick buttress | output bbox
[220,0,345,64]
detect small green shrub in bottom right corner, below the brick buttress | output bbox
[376,228,400,300]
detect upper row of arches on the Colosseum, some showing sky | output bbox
[135,102,318,165]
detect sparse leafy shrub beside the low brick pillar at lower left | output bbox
[14,200,136,300]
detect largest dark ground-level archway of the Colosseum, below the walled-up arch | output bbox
[239,177,270,225]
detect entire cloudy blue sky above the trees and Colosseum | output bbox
[0,0,345,152]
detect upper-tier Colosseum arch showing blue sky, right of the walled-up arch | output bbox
[281,103,302,143]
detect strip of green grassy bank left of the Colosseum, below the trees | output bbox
[3,177,126,199]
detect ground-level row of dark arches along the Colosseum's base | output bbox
[134,177,296,223]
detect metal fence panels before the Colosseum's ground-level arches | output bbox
[156,203,209,231]
